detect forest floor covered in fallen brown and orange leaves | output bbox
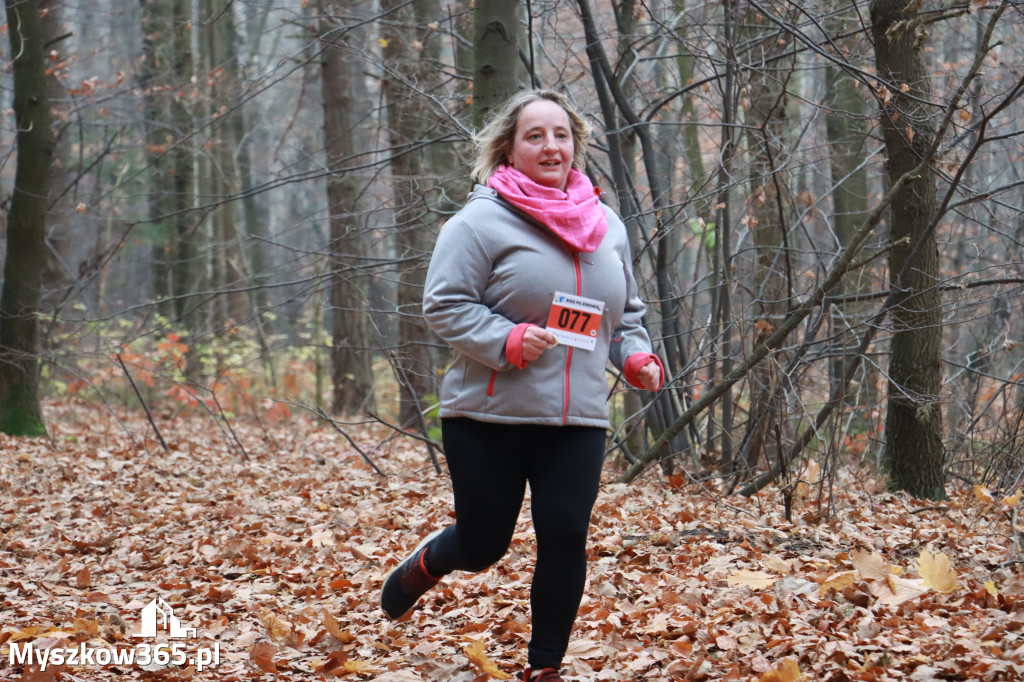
[0,401,1024,682]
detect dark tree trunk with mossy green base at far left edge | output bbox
[0,0,53,435]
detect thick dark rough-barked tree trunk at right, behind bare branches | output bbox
[871,0,945,499]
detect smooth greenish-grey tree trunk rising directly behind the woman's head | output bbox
[473,0,525,130]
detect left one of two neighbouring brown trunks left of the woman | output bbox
[321,0,375,415]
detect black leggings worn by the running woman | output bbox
[426,418,605,670]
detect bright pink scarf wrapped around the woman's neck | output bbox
[487,165,608,253]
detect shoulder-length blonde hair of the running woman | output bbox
[471,90,591,184]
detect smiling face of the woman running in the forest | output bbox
[509,99,575,190]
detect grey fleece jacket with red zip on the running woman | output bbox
[423,185,651,428]
